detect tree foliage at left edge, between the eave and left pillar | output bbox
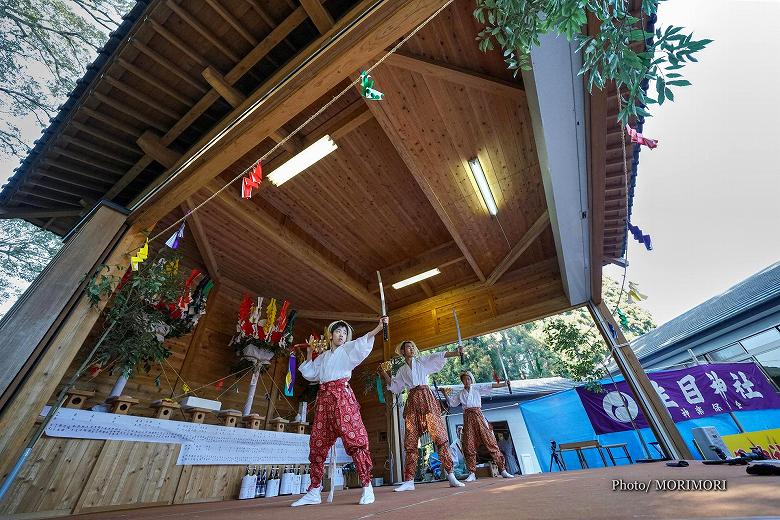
[0,219,60,316]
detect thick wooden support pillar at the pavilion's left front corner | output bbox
[0,203,157,476]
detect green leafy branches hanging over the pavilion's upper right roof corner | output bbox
[474,0,712,124]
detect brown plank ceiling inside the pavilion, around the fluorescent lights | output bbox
[193,1,562,315]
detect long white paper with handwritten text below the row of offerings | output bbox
[46,408,352,465]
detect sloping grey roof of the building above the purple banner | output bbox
[631,262,780,360]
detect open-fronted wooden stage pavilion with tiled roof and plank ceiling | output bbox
[0,0,700,518]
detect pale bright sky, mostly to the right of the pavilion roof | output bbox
[0,0,780,325]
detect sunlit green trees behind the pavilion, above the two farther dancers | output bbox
[434,277,655,385]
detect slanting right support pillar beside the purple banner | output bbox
[588,302,693,460]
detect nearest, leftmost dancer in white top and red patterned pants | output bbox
[292,316,388,507]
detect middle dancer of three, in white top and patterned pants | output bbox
[379,340,464,491]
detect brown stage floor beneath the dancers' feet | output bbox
[67,461,780,520]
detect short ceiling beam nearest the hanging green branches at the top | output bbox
[385,52,525,99]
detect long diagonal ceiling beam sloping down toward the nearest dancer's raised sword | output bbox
[207,182,379,309]
